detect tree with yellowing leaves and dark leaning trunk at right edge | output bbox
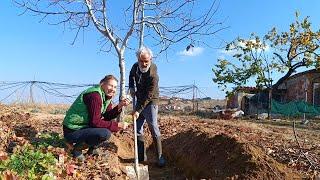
[265,12,320,89]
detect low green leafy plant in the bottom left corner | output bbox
[0,146,57,179]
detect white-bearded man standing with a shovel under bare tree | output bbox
[129,47,165,167]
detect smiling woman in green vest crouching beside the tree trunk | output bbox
[63,75,130,161]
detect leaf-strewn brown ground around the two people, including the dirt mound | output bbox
[0,105,320,179]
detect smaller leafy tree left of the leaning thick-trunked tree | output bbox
[212,34,276,90]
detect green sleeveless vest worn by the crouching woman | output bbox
[63,85,111,130]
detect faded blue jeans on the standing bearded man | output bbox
[137,103,161,138]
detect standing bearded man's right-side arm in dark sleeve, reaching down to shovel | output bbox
[136,65,159,114]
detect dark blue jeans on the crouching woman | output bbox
[64,128,111,146]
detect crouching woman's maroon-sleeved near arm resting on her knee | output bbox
[83,92,119,132]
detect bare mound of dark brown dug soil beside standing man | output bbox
[164,130,299,179]
